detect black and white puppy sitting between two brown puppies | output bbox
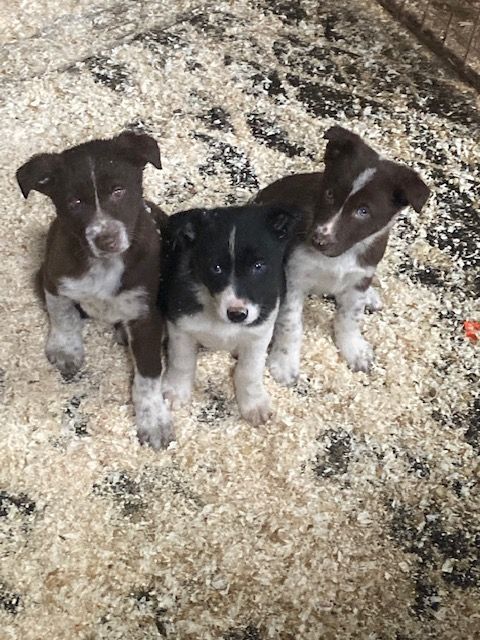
[162,206,298,425]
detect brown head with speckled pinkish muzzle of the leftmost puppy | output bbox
[16,131,161,257]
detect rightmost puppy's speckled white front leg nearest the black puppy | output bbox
[268,289,303,386]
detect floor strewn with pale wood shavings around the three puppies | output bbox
[0,0,480,640]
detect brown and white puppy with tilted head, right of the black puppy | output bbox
[254,126,430,385]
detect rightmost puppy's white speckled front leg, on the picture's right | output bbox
[335,282,373,372]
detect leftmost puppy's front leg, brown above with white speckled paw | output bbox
[128,312,175,449]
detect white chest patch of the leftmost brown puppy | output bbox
[58,257,148,324]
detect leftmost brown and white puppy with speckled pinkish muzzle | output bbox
[16,132,173,448]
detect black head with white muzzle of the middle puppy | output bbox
[170,206,300,326]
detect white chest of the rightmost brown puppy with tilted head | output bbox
[287,246,365,295]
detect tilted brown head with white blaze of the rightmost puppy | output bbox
[311,126,430,257]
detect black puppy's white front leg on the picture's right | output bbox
[234,331,272,427]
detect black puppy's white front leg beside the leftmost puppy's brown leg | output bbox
[162,322,198,409]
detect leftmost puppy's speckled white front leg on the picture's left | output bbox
[45,290,84,379]
